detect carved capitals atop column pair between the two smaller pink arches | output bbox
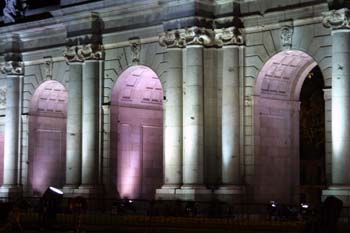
[64,44,102,62]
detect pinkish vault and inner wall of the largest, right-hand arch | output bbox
[254,50,325,203]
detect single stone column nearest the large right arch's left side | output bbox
[215,27,243,198]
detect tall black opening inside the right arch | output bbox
[299,66,326,204]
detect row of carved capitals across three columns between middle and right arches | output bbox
[159,27,243,48]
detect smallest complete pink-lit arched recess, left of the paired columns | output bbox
[29,81,67,195]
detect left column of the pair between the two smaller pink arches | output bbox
[64,46,83,194]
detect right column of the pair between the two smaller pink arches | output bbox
[79,44,102,195]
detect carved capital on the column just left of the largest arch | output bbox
[214,27,243,47]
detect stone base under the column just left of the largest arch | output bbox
[214,185,245,203]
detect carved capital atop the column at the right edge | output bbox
[323,8,350,30]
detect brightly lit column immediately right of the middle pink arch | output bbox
[157,32,183,198]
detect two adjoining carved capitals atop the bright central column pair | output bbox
[159,27,213,48]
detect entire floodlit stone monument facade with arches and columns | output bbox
[0,0,350,205]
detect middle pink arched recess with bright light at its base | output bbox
[111,66,163,199]
